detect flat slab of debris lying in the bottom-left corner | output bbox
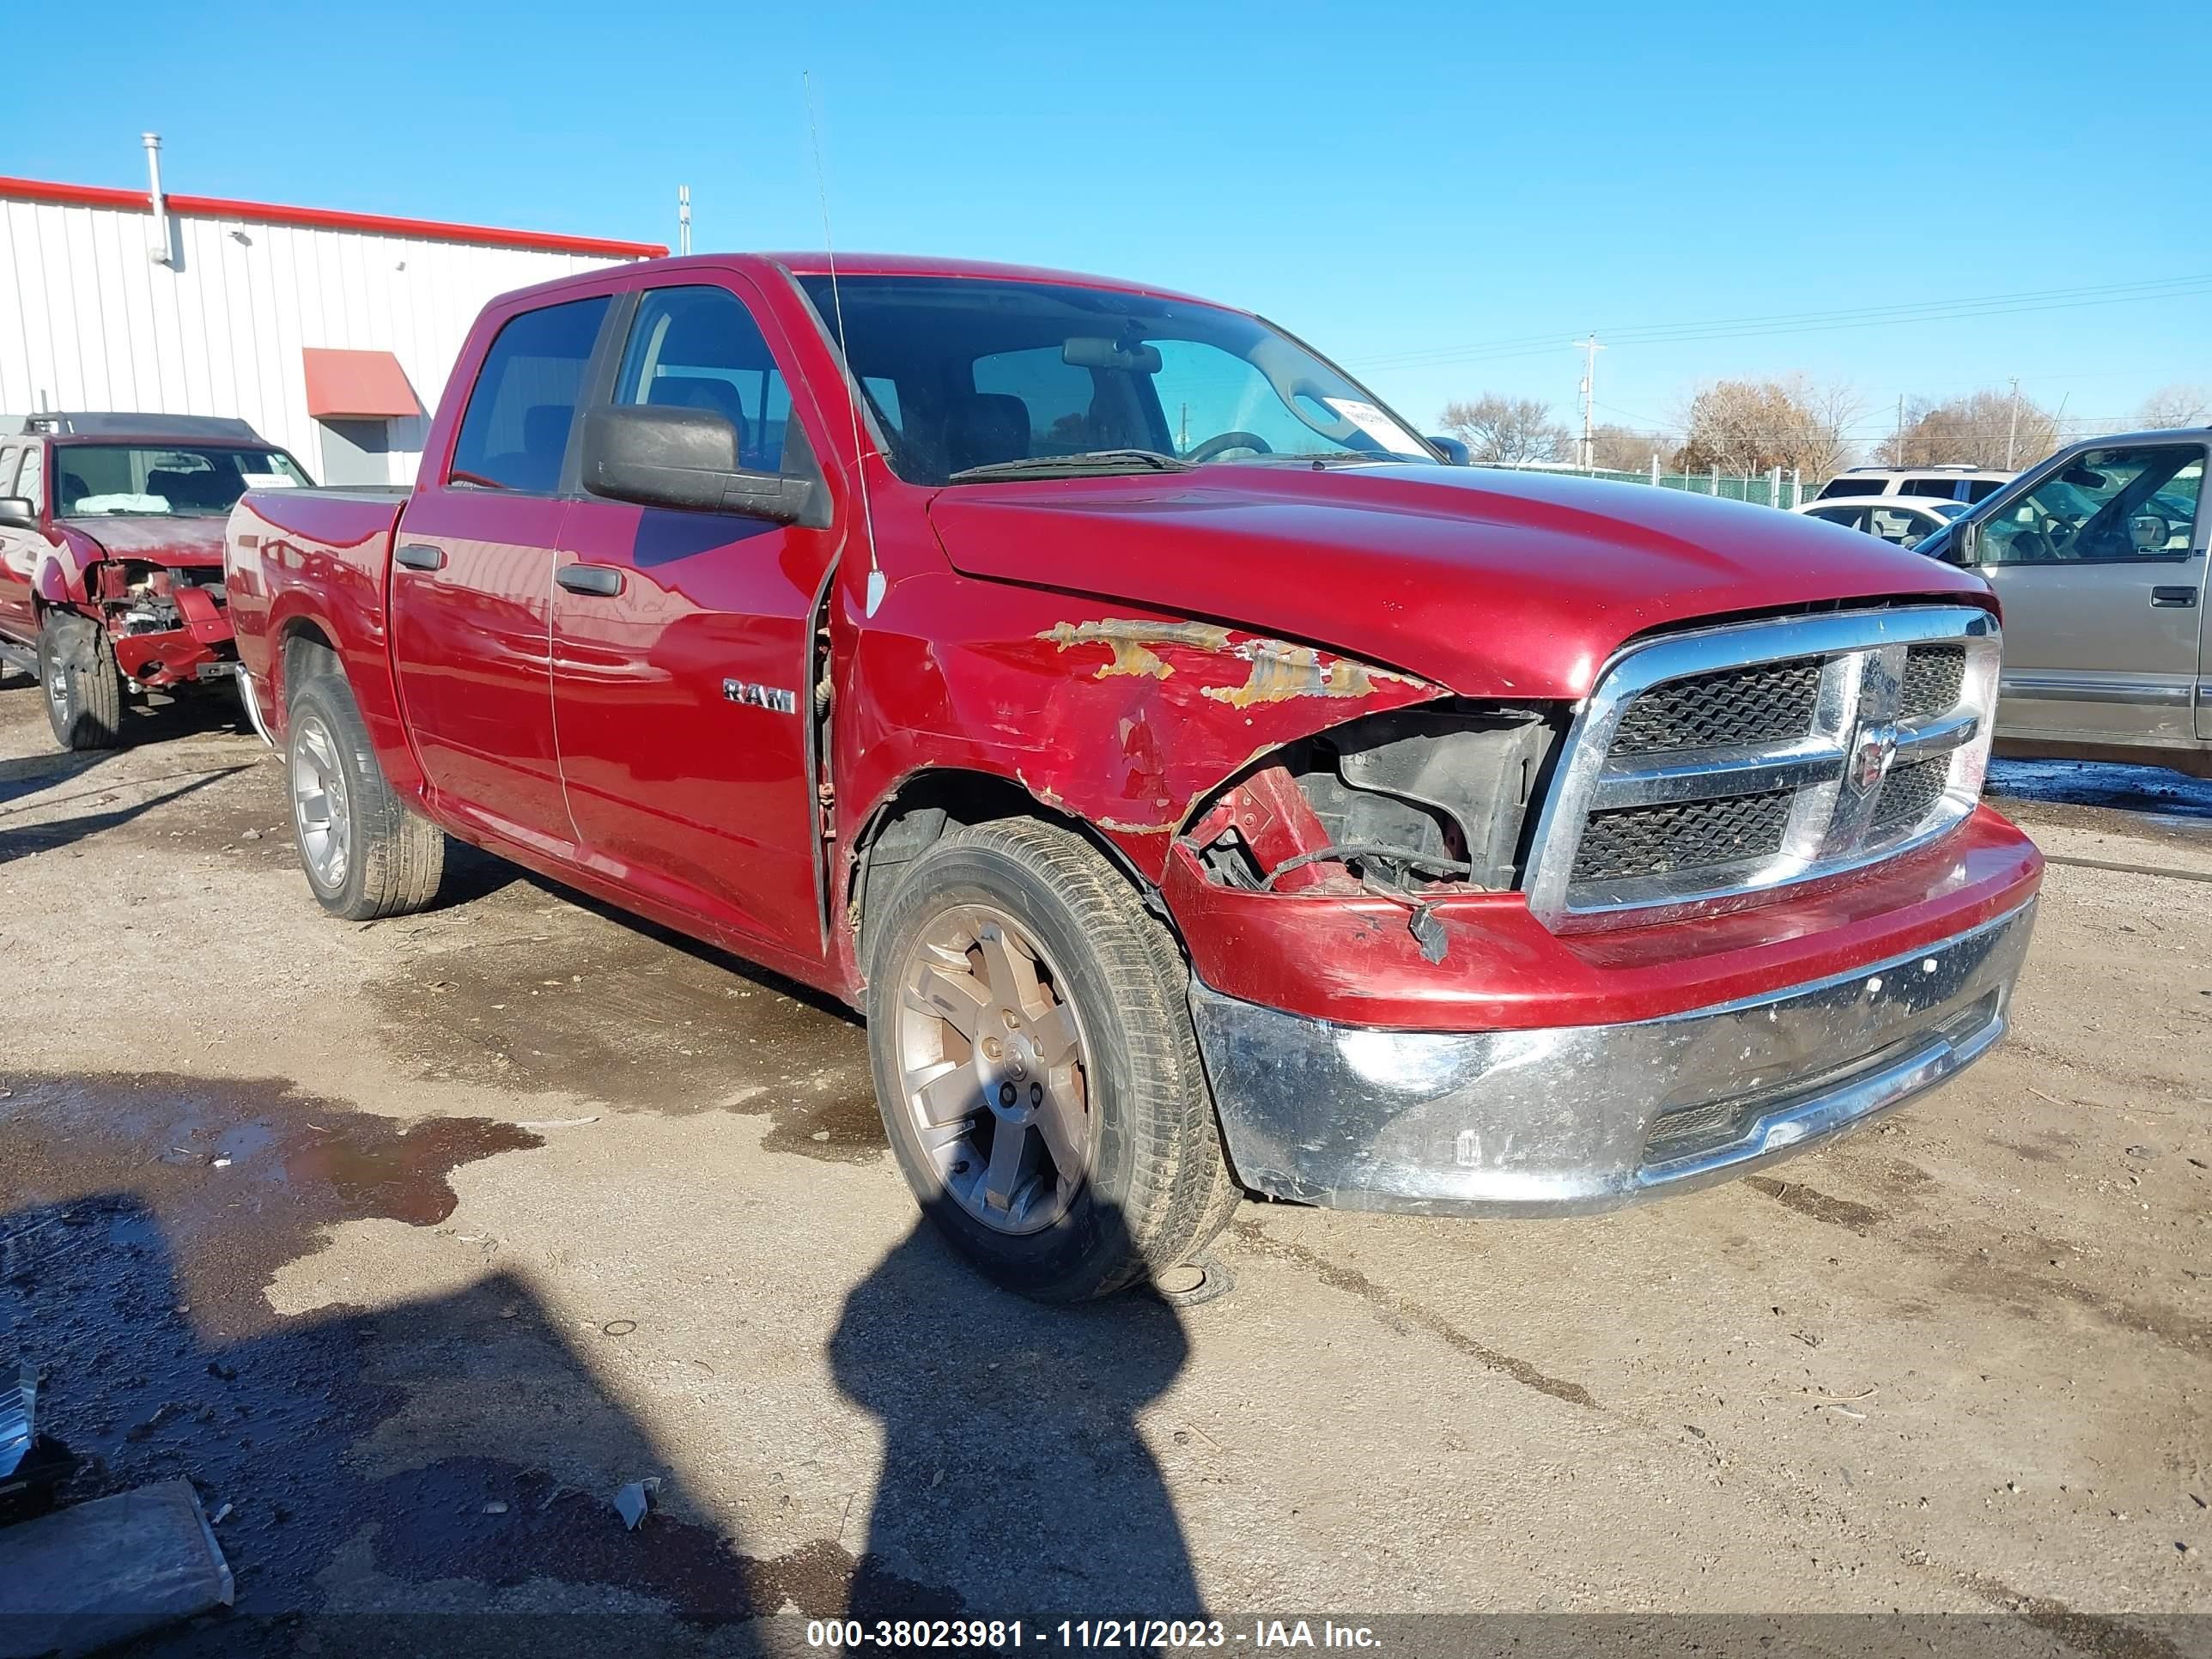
[0,1480,234,1659]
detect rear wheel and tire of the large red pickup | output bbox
[285,675,445,922]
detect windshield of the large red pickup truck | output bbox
[799,276,1433,484]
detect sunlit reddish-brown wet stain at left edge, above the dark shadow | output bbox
[0,1075,544,1336]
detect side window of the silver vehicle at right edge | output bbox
[1978,447,2205,564]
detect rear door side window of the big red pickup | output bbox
[447,295,611,495]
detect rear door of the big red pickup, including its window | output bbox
[392,295,611,856]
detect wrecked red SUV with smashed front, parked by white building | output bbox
[0,414,312,750]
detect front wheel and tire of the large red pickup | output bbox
[867,818,1228,1303]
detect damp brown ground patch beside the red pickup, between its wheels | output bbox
[368,911,884,1161]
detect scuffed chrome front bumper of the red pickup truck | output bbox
[1190,900,2035,1214]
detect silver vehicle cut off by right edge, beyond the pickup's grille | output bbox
[1917,429,2212,776]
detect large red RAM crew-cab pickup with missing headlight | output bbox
[228,254,2042,1301]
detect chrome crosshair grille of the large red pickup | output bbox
[1526,606,1997,927]
